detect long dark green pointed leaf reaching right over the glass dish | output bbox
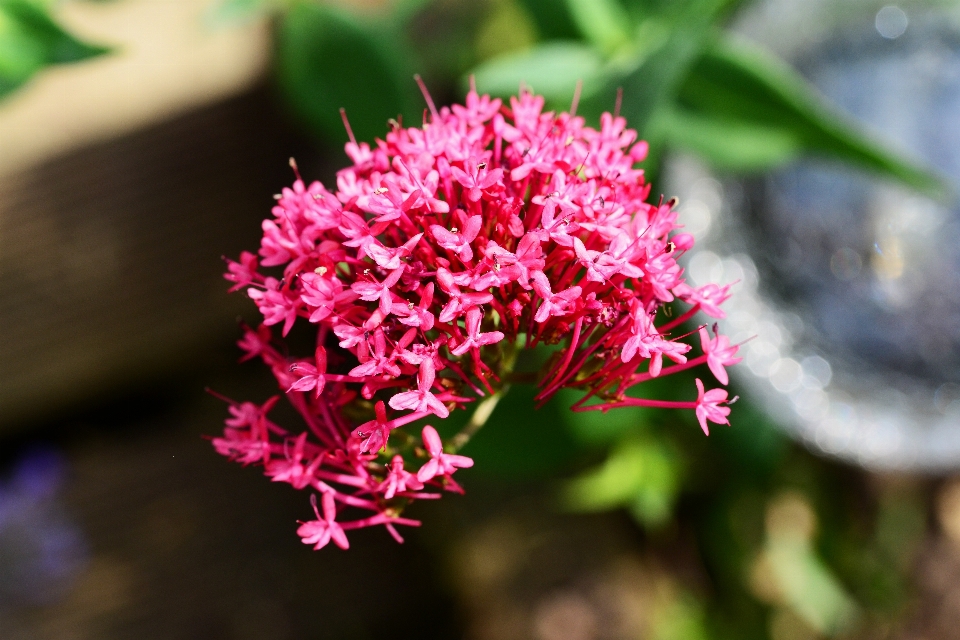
[679,38,947,197]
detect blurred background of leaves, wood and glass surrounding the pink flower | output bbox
[0,0,960,640]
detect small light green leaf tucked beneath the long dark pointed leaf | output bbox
[659,108,803,172]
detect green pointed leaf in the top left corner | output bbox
[0,0,110,96]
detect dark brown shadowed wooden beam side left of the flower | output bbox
[0,89,322,431]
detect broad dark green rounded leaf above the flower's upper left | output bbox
[277,2,423,141]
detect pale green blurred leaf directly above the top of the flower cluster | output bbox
[471,42,604,103]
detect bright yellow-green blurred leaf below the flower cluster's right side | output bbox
[563,436,681,526]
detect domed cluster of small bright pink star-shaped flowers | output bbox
[213,85,740,548]
